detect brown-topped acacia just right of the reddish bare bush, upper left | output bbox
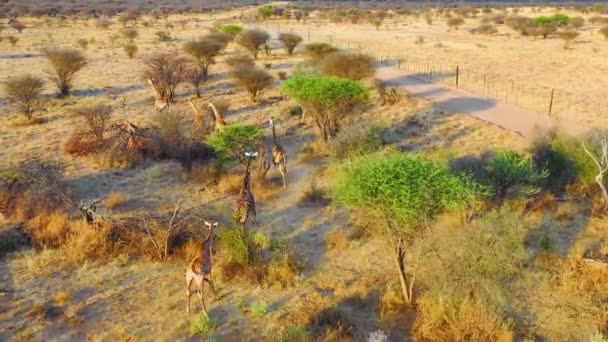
[183,38,226,97]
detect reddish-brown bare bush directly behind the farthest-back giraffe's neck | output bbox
[143,52,189,109]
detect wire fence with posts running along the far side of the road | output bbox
[267,24,608,125]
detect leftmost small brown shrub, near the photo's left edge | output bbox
[4,75,44,120]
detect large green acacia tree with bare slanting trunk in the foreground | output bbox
[332,153,475,302]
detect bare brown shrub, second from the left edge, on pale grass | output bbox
[43,49,87,96]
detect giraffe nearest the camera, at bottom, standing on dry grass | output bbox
[186,221,218,316]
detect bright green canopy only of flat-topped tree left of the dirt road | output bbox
[283,75,369,107]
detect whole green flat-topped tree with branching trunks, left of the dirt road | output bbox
[283,75,369,142]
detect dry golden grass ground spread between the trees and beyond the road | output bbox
[0,2,608,341]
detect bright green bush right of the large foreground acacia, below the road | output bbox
[485,151,549,201]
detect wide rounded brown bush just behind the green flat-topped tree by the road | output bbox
[320,52,376,81]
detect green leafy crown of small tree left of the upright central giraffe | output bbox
[207,124,264,161]
